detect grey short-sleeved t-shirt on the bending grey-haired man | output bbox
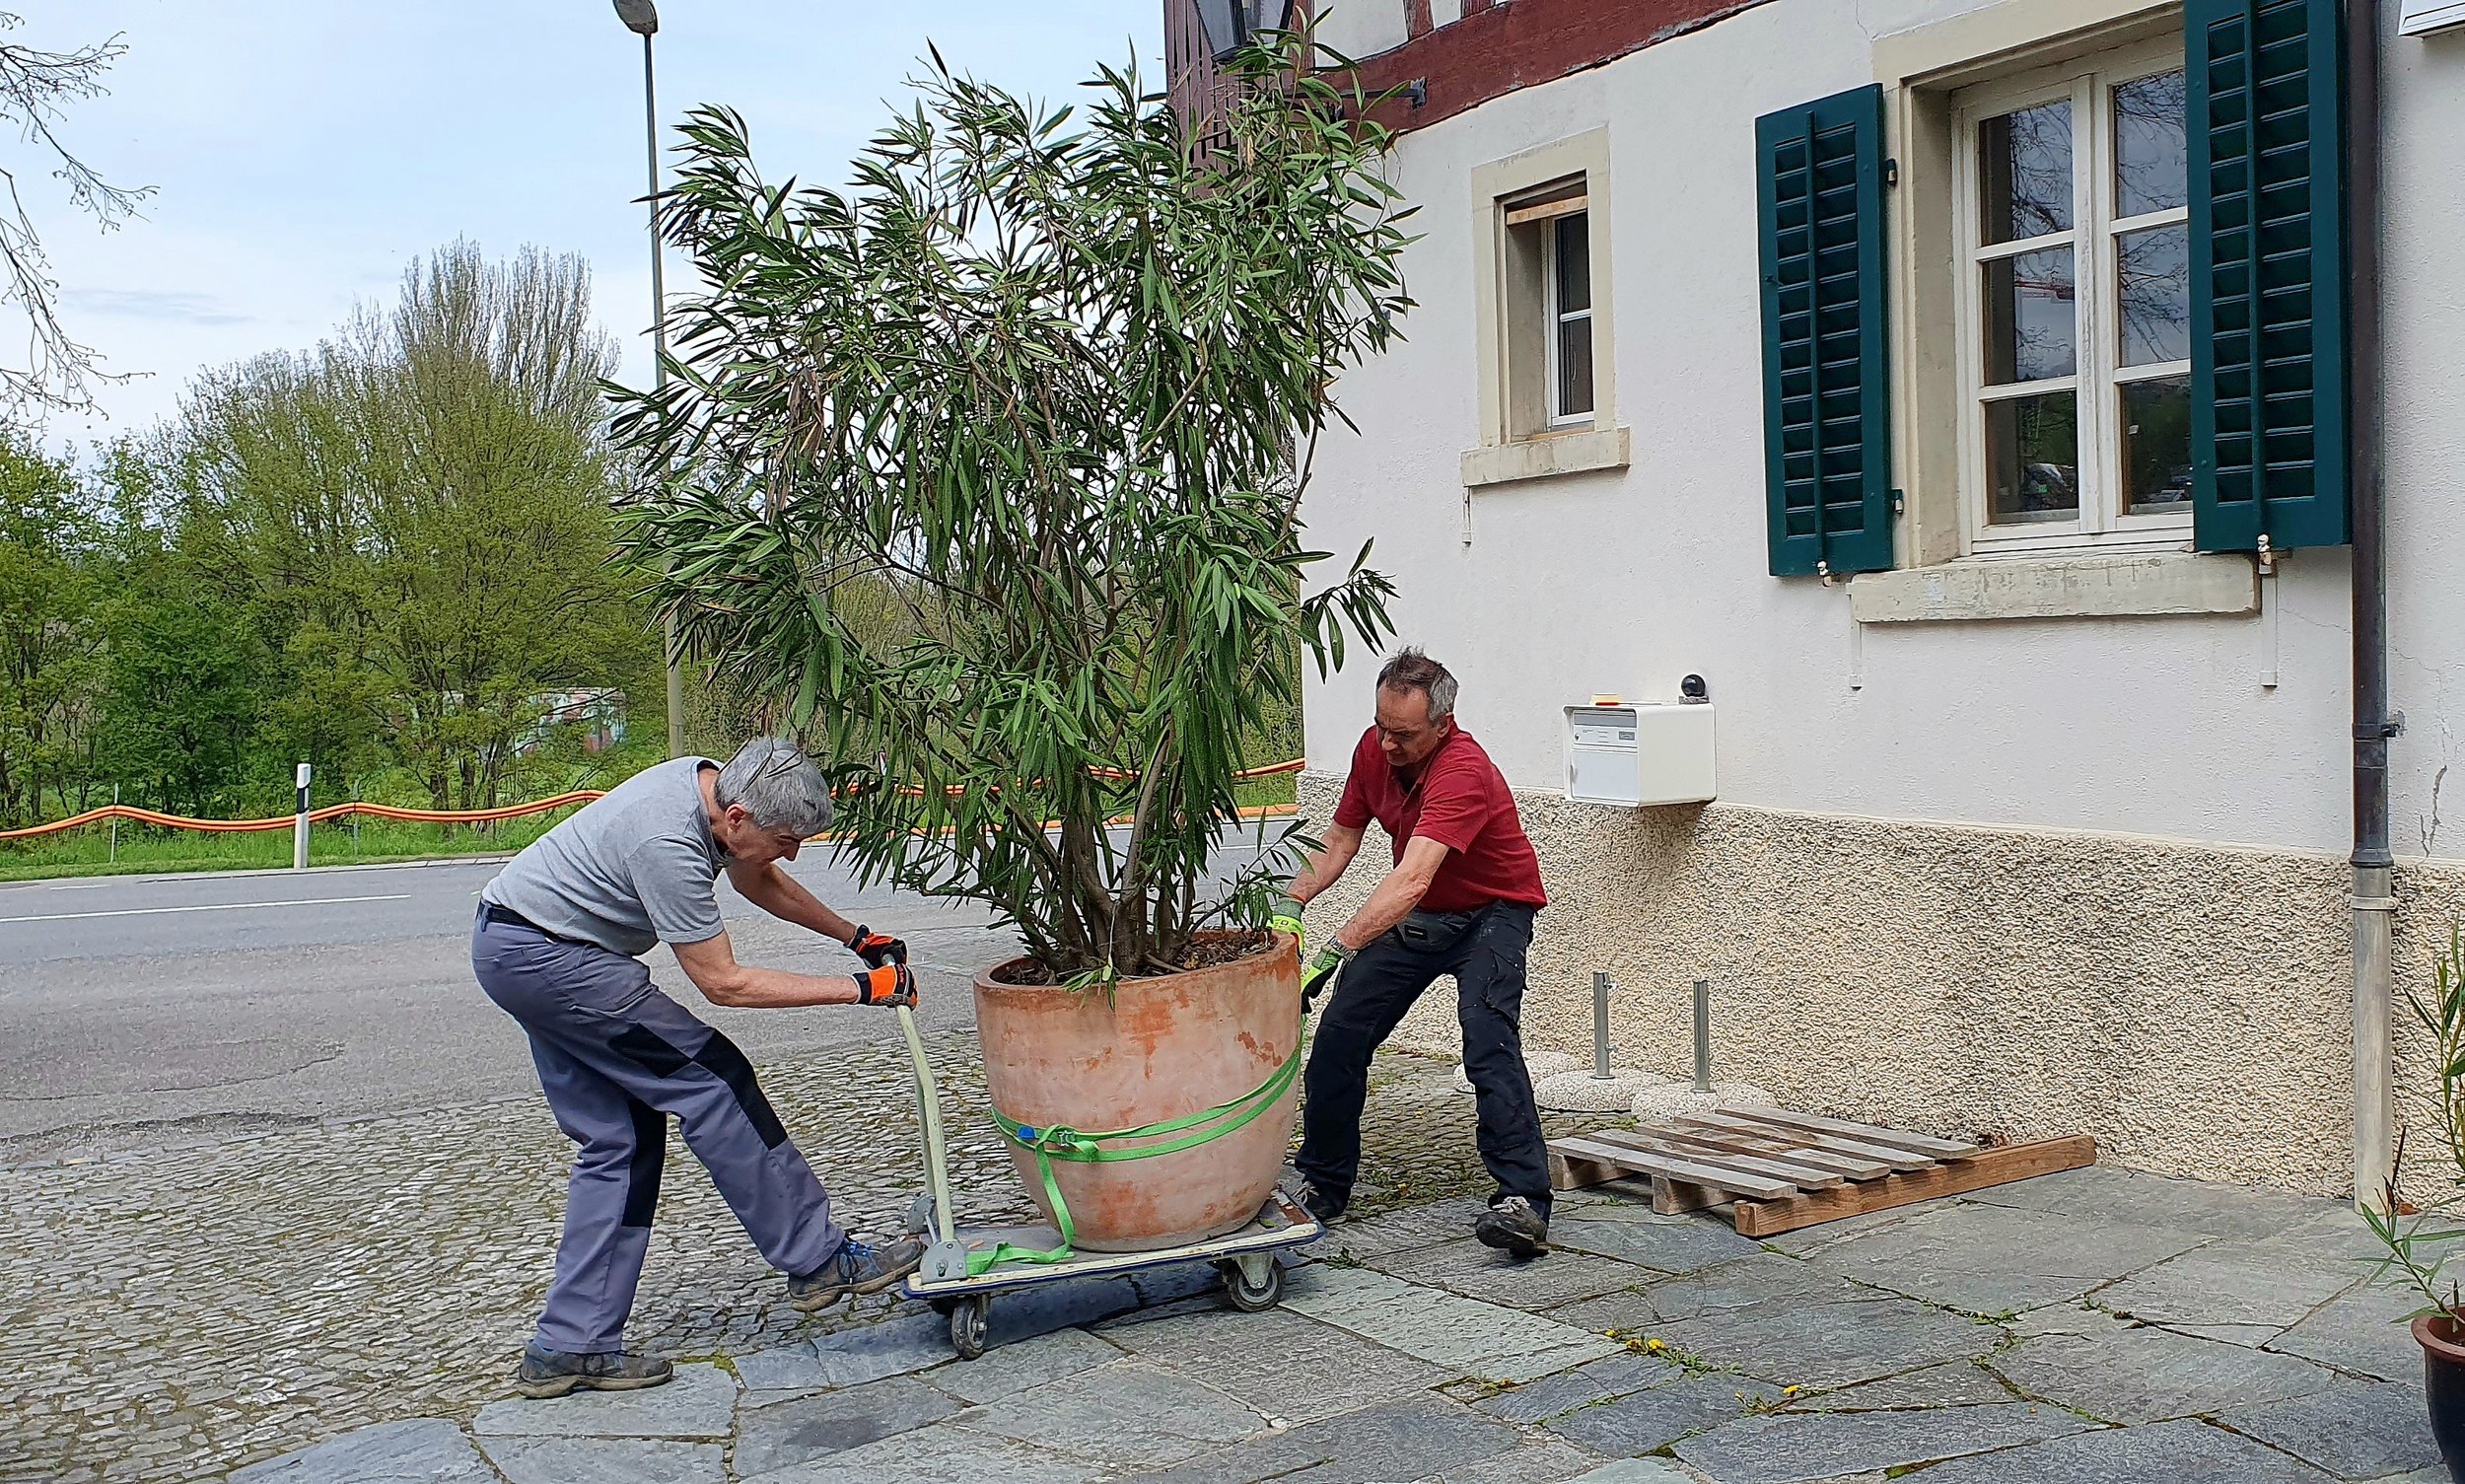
[478,757,728,956]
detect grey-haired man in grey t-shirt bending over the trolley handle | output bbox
[471,738,925,1395]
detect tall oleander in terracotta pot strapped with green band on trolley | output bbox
[616,37,1410,1250]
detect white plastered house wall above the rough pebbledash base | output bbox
[1306,0,2465,858]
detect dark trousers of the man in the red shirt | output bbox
[1292,902,1551,1216]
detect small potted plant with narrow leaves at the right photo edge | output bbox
[2361,927,2465,1479]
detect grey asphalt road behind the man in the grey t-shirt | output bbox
[0,853,1014,1164]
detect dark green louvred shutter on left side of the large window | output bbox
[1755,87,1891,577]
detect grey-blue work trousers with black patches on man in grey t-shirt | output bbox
[471,910,846,1354]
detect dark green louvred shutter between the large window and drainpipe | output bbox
[2184,0,2350,552]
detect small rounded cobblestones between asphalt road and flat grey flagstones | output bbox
[0,1038,1518,1484]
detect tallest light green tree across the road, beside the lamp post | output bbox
[177,242,654,809]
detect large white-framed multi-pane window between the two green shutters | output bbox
[1955,44,2192,555]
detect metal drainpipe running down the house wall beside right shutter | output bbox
[2345,0,2399,1203]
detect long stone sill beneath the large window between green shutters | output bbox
[1849,552,2261,624]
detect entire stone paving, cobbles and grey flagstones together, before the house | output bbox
[0,1045,2445,1484]
